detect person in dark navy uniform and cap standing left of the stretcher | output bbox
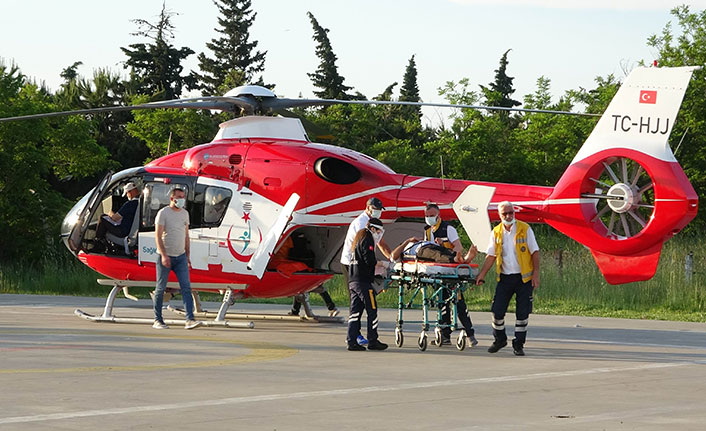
[346,218,387,351]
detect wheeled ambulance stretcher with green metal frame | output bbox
[388,260,478,351]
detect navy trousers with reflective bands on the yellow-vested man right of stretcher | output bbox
[490,274,533,346]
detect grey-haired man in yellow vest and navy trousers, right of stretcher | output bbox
[476,201,539,356]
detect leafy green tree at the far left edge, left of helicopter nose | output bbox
[0,63,108,263]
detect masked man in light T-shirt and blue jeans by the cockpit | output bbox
[152,188,203,329]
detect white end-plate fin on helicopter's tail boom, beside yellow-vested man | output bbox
[453,185,495,250]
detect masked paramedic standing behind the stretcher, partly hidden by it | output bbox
[424,204,478,346]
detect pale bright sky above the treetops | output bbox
[0,0,706,123]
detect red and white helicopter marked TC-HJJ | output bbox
[0,67,698,326]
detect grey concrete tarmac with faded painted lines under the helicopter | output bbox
[0,294,706,431]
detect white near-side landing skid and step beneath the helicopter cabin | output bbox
[74,279,255,329]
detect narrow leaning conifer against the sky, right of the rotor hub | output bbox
[307,12,352,100]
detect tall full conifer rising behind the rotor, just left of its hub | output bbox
[194,0,267,96]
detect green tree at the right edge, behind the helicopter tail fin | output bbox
[647,5,706,231]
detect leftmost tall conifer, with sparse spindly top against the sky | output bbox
[120,3,196,99]
